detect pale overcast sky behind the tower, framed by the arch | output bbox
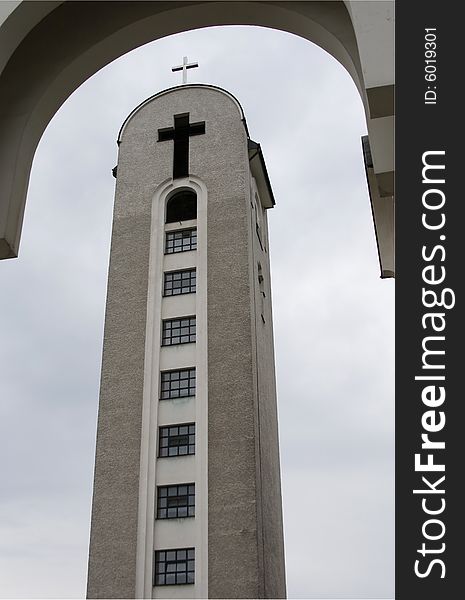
[0,27,394,599]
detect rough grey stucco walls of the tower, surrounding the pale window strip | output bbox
[88,86,285,598]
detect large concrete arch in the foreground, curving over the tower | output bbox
[0,0,394,276]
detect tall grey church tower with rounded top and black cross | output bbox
[88,85,286,598]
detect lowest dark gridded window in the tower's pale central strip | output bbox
[154,548,195,585]
